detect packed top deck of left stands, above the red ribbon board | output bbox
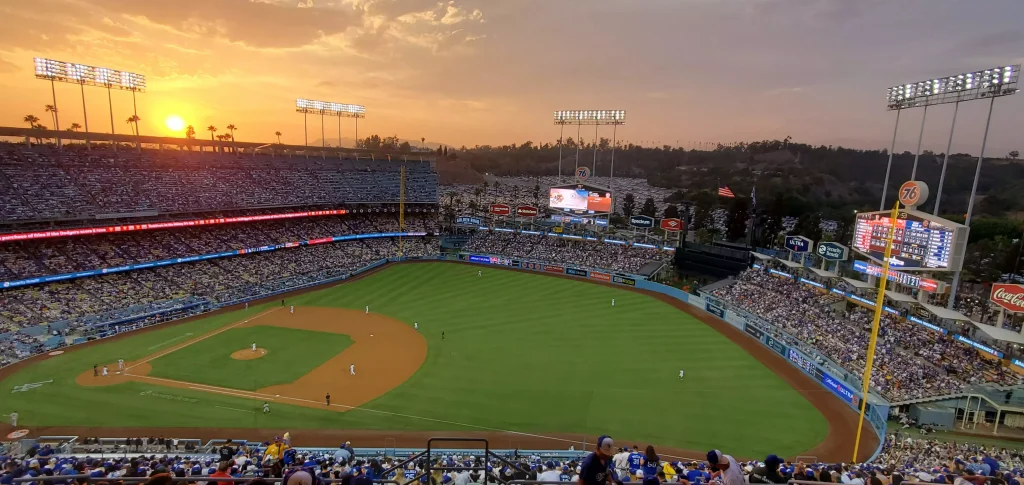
[0,144,437,222]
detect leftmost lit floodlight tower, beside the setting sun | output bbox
[35,57,145,151]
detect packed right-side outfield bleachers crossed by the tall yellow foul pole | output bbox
[714,269,1024,402]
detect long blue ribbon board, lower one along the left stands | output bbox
[0,232,427,288]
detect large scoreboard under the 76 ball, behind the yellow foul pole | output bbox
[851,210,970,271]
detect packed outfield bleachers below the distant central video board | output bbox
[465,231,671,273]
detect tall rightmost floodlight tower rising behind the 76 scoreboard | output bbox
[880,64,1021,308]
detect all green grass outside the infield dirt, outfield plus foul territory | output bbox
[0,263,828,456]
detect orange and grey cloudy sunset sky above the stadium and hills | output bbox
[0,0,1024,156]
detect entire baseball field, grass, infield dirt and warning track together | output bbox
[0,263,874,460]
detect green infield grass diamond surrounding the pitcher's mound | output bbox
[150,326,352,391]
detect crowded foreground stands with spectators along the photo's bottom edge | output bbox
[6,433,1024,485]
